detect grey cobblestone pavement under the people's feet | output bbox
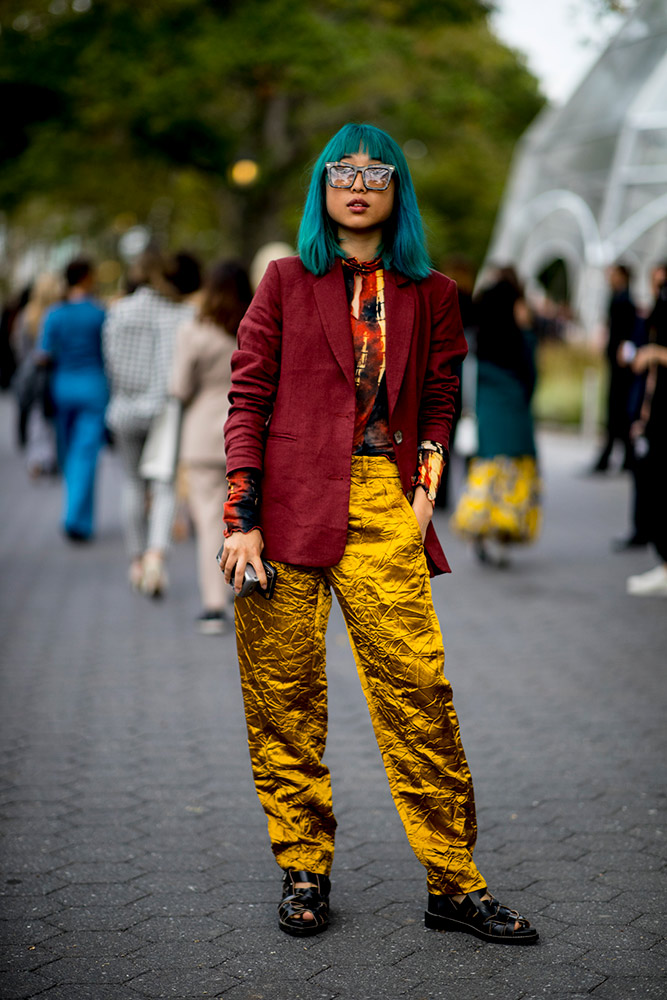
[0,399,667,1000]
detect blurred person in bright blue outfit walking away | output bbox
[41,258,109,542]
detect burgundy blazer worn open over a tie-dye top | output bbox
[225,257,467,575]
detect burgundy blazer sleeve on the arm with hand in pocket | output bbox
[419,279,468,449]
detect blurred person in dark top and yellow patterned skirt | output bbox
[451,267,541,566]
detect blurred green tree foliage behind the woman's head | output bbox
[0,0,542,260]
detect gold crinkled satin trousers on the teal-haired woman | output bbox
[235,456,485,895]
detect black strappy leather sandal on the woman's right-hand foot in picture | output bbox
[424,889,540,944]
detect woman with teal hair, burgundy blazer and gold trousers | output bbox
[219,125,538,944]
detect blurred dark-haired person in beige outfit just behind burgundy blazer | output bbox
[171,261,252,635]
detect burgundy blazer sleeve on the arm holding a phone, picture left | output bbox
[225,261,282,473]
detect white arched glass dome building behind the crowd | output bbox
[487,0,667,334]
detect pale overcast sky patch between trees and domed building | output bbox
[493,0,623,104]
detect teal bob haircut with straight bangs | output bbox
[298,124,431,281]
